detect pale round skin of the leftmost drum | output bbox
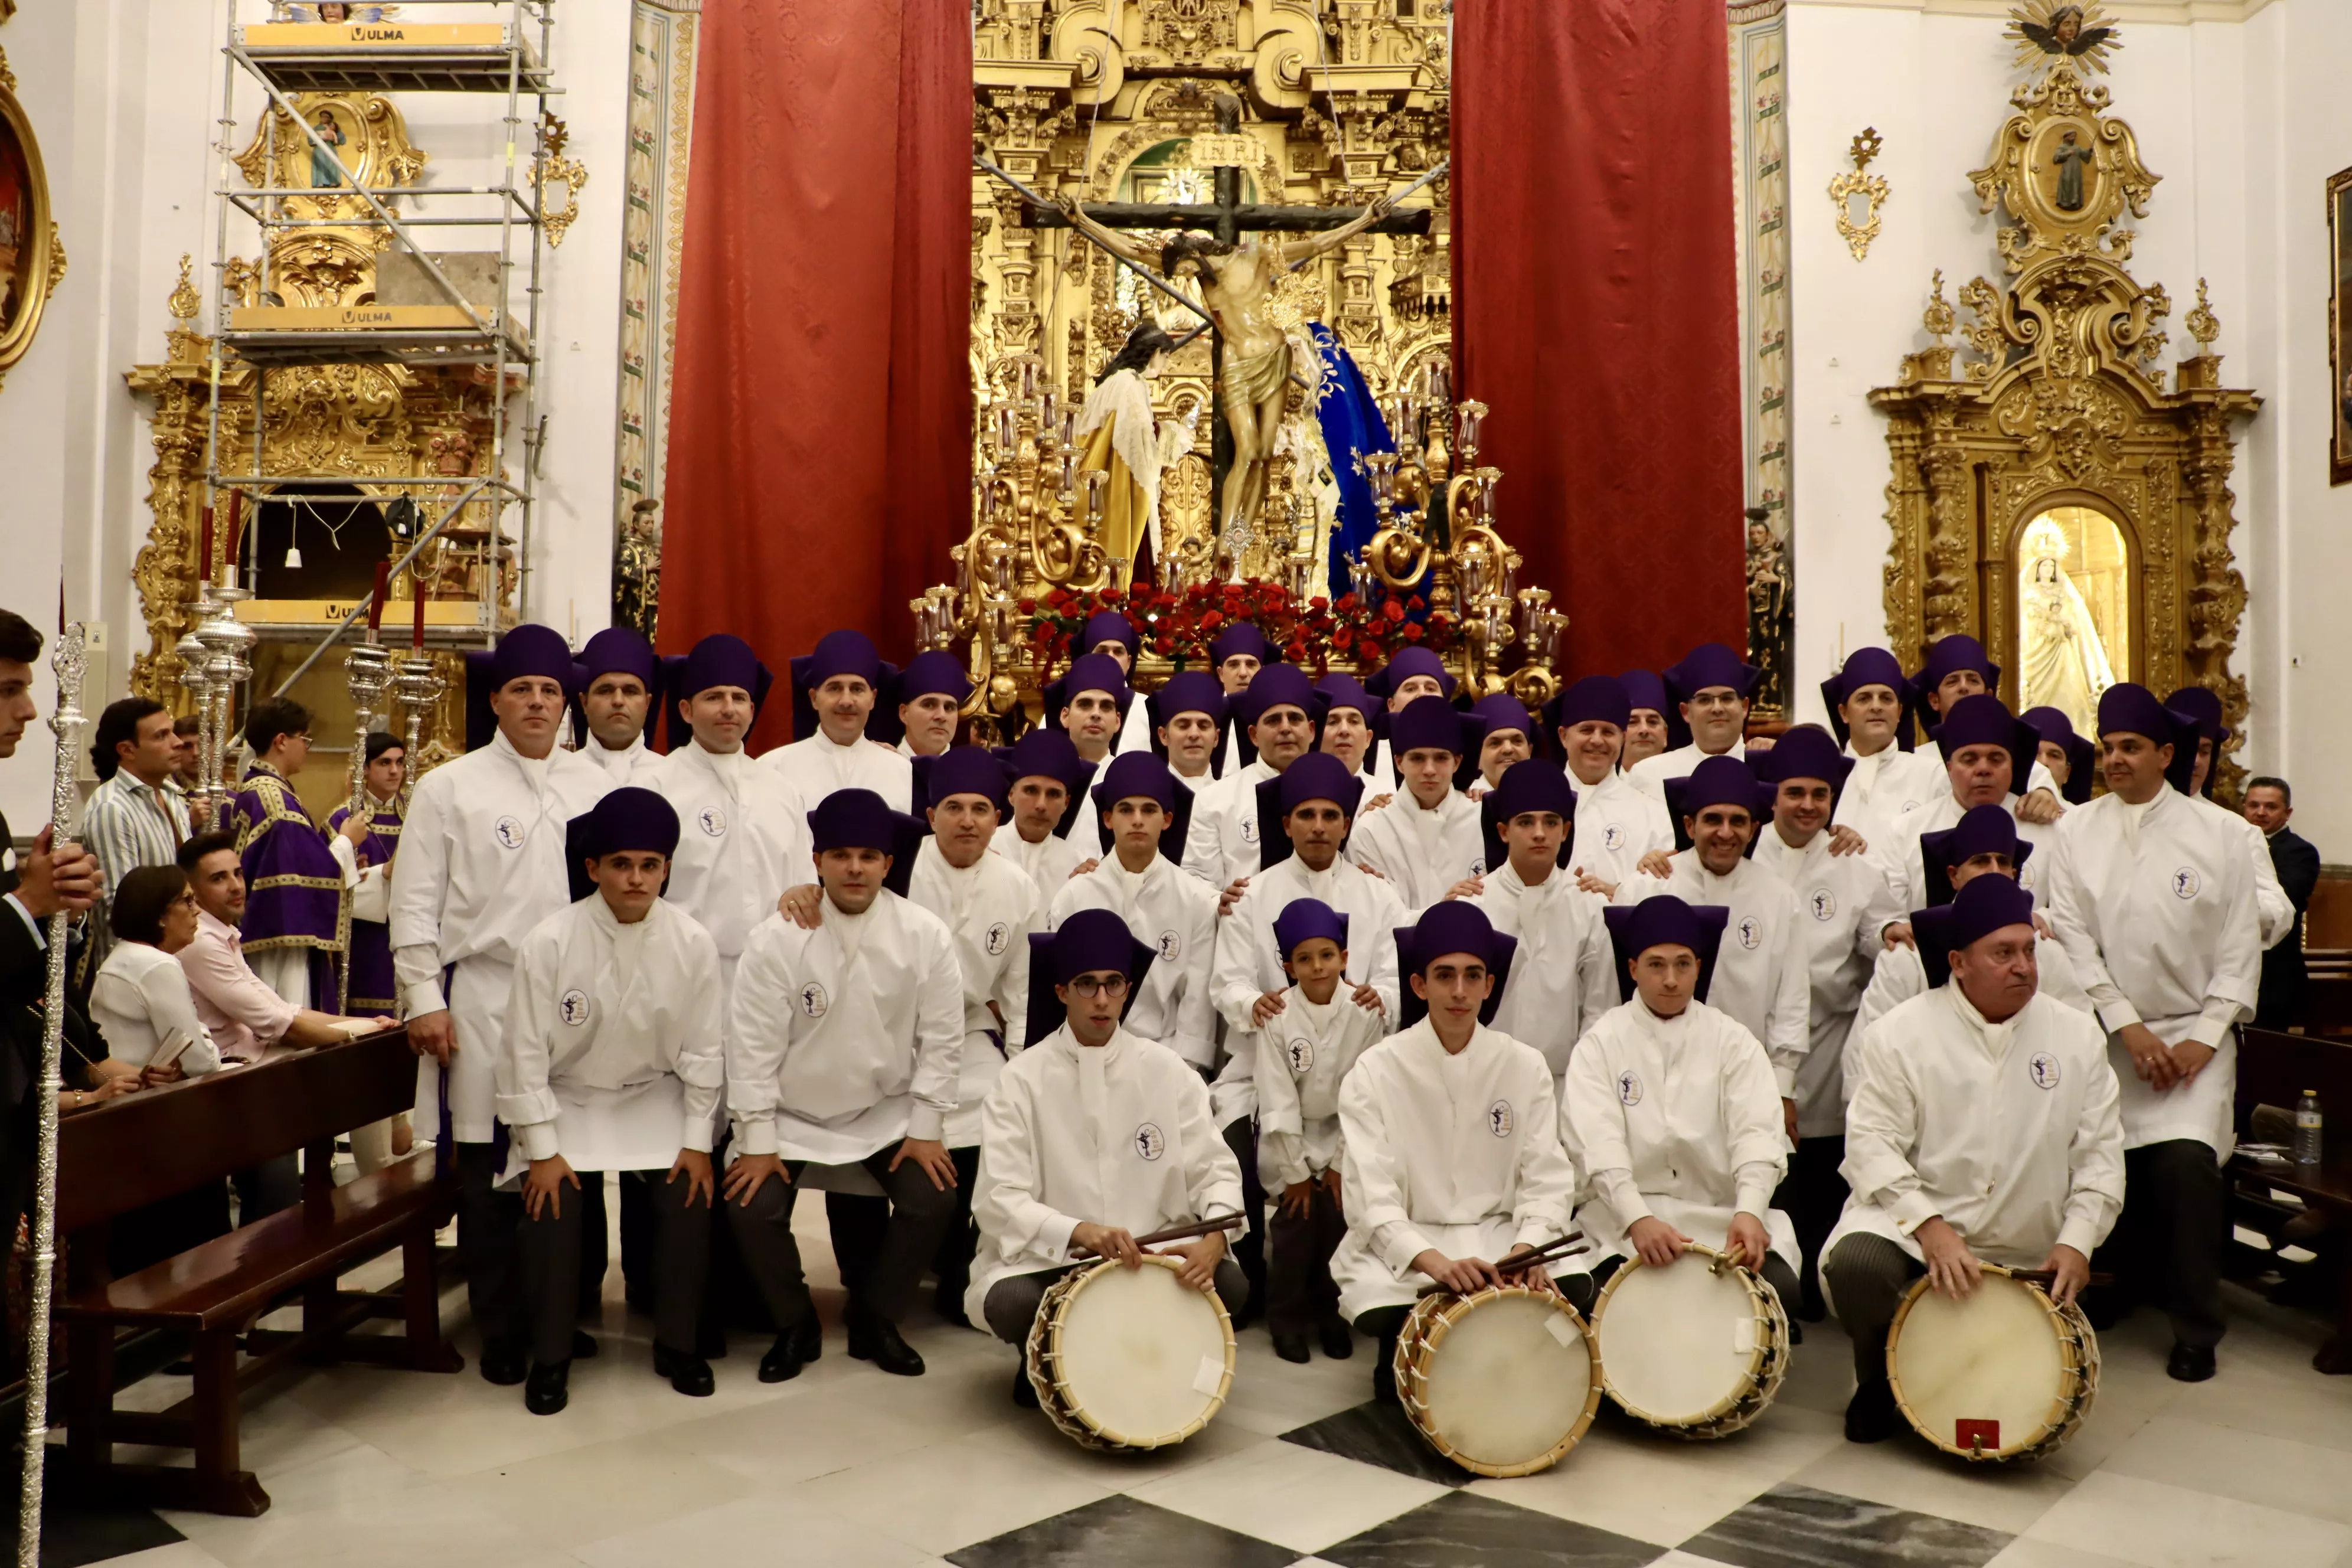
[1051,1257,1233,1448]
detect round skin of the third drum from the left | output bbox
[1592,1253,1766,1427]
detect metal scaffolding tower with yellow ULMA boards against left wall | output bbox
[205,0,560,694]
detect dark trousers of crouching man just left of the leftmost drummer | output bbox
[727,1142,955,1333]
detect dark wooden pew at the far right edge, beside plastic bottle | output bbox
[2225,1030,2352,1373]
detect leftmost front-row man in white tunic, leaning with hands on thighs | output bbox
[496,785,724,1415]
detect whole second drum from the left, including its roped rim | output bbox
[1395,1286,1602,1476]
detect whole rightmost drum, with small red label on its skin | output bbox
[1886,1262,2098,1462]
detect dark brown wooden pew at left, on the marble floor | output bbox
[52,1030,463,1516]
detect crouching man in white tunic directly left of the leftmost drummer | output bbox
[722,790,964,1382]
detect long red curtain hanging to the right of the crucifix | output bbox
[1451,0,1747,677]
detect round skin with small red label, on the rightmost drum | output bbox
[1886,1274,2067,1458]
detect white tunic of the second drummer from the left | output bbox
[1331,1018,1576,1319]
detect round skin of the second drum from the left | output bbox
[1427,1293,1592,1469]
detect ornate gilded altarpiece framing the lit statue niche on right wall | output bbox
[1870,7,2260,790]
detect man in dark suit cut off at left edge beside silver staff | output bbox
[0,609,103,1237]
